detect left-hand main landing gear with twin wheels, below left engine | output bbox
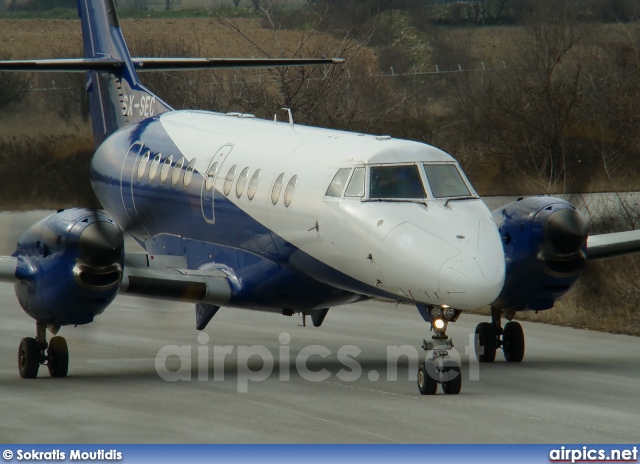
[18,322,69,379]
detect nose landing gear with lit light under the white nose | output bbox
[418,305,462,395]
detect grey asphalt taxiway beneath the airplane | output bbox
[0,213,640,443]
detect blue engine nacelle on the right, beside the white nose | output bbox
[492,197,588,311]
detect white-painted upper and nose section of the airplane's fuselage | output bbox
[102,111,505,309]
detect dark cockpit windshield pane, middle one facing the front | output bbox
[369,165,426,199]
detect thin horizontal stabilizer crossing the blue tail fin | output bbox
[0,58,344,72]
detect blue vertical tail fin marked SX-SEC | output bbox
[78,0,172,146]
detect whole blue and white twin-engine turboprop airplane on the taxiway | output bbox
[0,0,638,395]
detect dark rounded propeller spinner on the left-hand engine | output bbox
[79,221,124,266]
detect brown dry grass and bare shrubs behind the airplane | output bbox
[0,0,640,334]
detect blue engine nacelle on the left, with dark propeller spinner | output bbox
[13,208,124,326]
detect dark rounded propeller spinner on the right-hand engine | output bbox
[543,209,588,255]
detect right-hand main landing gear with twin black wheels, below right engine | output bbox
[475,306,524,362]
